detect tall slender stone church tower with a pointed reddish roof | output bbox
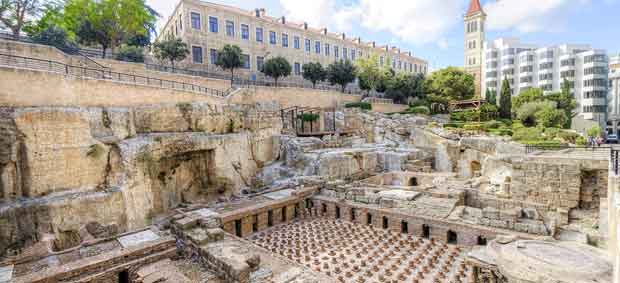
[464,0,487,97]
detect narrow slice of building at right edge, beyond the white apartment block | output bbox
[607,54,620,135]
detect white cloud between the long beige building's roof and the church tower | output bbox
[280,0,464,46]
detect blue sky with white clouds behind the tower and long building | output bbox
[147,0,620,70]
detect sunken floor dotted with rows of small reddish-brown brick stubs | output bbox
[250,218,469,283]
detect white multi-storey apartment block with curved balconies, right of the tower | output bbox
[483,38,609,128]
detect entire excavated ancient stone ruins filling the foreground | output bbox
[0,38,618,283]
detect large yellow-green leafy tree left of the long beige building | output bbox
[63,0,158,58]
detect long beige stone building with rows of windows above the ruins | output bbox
[160,0,428,82]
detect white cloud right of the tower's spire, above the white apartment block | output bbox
[484,0,592,33]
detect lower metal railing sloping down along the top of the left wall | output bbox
[0,54,233,97]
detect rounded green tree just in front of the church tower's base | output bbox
[426,67,475,100]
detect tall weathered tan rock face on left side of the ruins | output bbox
[0,104,281,254]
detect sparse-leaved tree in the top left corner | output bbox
[0,0,41,37]
